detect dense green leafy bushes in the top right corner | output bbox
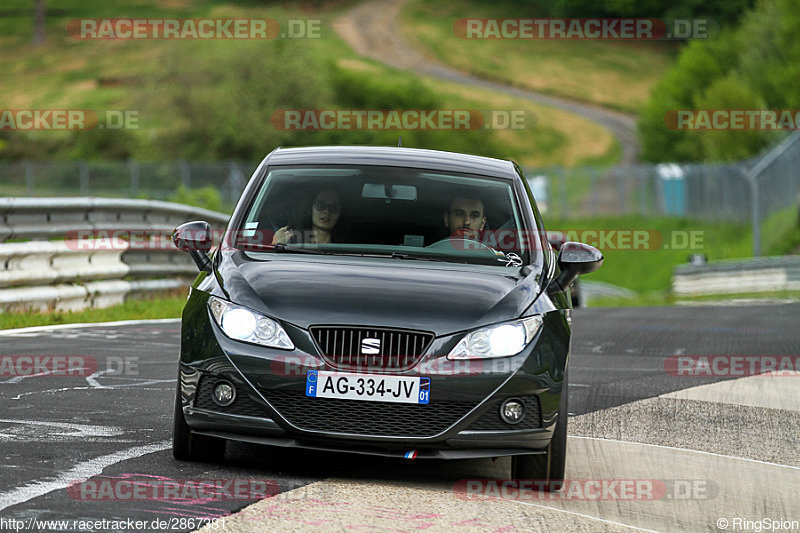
[639,0,800,161]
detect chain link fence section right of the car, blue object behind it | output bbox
[526,132,800,252]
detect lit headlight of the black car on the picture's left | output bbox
[208,296,294,350]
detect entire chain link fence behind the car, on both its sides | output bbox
[0,132,800,255]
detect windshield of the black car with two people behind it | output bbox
[238,166,537,266]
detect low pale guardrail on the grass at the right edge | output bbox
[672,256,800,296]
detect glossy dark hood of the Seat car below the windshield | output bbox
[217,251,540,335]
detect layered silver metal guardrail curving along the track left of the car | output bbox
[0,198,229,310]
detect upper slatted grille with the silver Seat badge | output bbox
[310,326,433,371]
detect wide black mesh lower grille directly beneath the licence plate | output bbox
[261,389,477,437]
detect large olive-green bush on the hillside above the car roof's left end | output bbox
[141,39,333,160]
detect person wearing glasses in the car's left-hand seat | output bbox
[272,190,342,244]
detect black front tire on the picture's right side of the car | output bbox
[511,372,569,492]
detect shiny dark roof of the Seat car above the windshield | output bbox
[265,146,517,179]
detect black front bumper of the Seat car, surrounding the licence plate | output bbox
[179,290,569,459]
